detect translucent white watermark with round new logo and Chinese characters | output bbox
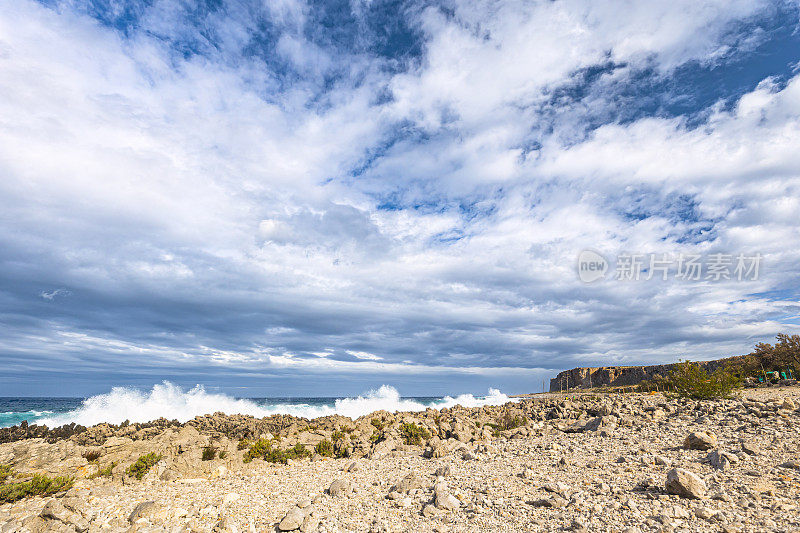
[578,250,763,283]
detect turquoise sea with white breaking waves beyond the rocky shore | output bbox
[0,382,512,428]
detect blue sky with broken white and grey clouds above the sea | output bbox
[0,0,800,397]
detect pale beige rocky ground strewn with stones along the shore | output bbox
[0,386,800,533]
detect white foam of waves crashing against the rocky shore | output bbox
[36,381,512,427]
